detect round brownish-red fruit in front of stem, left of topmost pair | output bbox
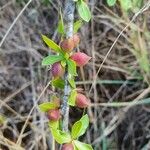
[60,38,74,52]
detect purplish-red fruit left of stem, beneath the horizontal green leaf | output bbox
[52,62,64,77]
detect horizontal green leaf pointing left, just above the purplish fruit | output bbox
[42,55,64,66]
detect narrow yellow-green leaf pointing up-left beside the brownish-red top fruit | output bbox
[42,35,61,52]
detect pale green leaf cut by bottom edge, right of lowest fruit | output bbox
[74,140,93,150]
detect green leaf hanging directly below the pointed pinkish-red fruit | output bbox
[67,59,77,76]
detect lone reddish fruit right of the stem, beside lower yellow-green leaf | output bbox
[76,93,89,108]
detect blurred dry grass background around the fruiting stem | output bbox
[0,0,150,150]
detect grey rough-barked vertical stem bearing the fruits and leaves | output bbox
[61,0,75,131]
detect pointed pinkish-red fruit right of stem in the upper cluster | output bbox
[70,52,91,67]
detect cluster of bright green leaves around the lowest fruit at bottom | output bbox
[49,115,93,150]
